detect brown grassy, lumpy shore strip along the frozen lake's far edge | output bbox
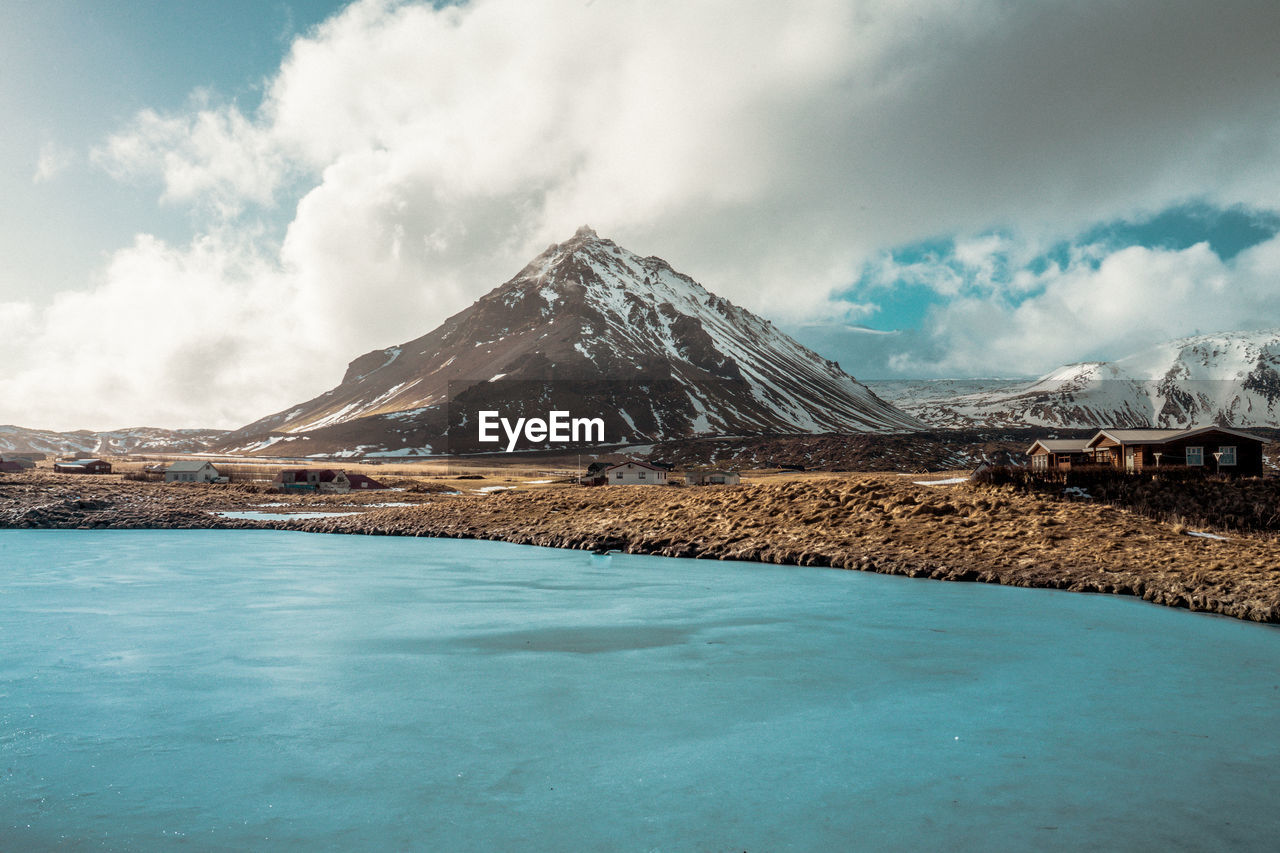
[0,474,1280,622]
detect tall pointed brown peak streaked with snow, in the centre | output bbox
[221,227,919,456]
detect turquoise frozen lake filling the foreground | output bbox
[0,530,1280,853]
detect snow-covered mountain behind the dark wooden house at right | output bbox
[882,329,1280,428]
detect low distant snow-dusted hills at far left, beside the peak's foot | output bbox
[0,425,227,457]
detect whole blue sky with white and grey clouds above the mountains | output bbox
[0,0,1280,429]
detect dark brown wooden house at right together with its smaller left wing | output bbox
[1027,427,1262,476]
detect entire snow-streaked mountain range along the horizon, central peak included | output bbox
[0,228,1280,457]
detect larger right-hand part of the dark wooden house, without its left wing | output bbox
[1085,427,1263,476]
